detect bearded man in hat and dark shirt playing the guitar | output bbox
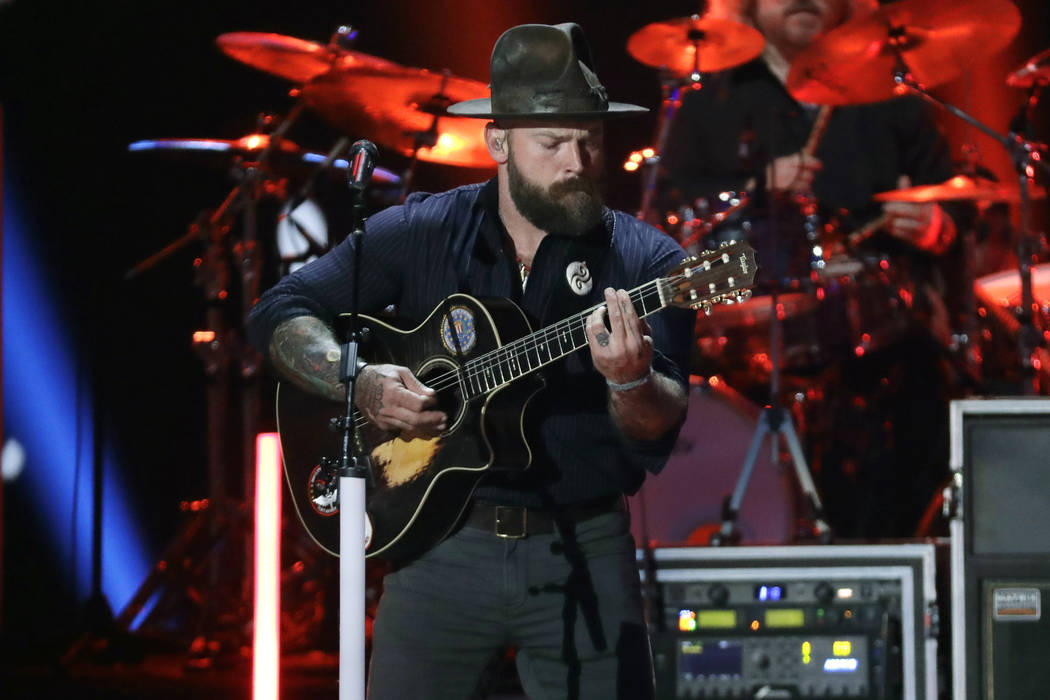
[250,24,693,700]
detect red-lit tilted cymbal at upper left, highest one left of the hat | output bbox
[215,31,400,83]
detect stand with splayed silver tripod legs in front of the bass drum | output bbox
[710,156,832,547]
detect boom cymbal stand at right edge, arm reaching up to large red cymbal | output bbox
[890,54,1050,394]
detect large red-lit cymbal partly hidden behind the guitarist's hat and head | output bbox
[302,66,496,168]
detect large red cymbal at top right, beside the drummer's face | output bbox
[788,0,1021,106]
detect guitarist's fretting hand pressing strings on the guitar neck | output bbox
[585,289,653,384]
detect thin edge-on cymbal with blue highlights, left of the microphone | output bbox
[128,133,401,185]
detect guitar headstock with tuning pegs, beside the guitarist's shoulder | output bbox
[662,241,757,314]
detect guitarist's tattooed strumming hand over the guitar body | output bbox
[354,364,448,437]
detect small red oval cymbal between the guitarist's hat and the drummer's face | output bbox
[627,15,765,76]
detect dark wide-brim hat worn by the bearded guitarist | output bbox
[448,23,649,119]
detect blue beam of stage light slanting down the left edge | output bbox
[2,178,149,610]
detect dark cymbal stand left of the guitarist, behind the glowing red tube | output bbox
[118,105,301,667]
